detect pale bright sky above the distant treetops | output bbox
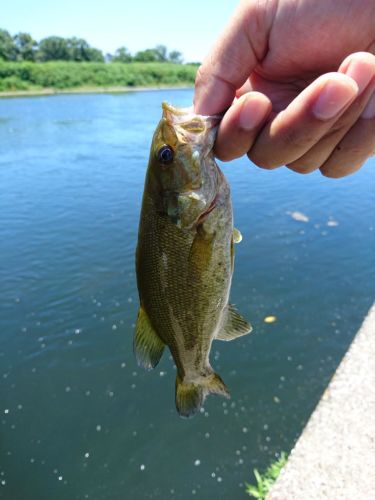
[0,0,238,62]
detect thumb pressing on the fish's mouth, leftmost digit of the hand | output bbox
[194,0,272,115]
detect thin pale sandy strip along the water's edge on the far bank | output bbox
[0,85,194,99]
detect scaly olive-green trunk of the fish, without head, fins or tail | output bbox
[137,166,232,378]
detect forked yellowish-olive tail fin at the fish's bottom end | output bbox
[176,372,230,417]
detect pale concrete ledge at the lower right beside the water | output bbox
[267,304,375,500]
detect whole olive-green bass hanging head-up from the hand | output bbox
[133,102,252,417]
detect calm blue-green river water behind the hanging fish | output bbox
[0,91,375,500]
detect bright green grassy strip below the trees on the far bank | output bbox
[0,61,197,92]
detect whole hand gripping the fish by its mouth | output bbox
[194,0,375,177]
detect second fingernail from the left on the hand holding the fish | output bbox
[312,79,358,120]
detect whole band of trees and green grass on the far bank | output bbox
[0,29,197,92]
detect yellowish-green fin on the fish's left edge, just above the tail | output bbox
[133,306,165,370]
